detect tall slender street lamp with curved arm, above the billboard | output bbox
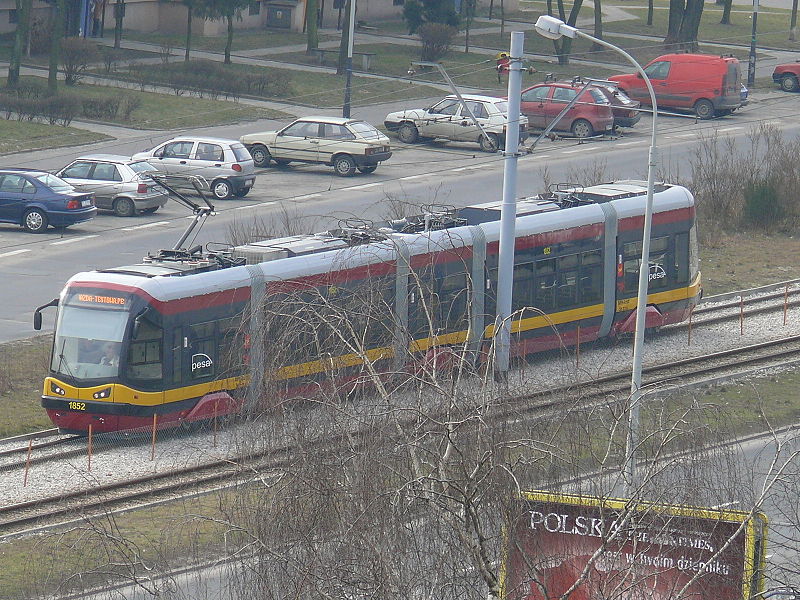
[535,15,658,497]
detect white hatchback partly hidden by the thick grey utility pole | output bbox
[383,94,528,152]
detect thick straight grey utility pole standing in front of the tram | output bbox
[495,31,525,377]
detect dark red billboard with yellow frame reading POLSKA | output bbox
[502,492,767,600]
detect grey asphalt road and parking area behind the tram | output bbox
[0,92,800,342]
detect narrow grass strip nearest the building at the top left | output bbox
[122,29,338,52]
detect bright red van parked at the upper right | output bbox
[609,54,742,119]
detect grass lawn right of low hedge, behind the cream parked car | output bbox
[129,61,441,109]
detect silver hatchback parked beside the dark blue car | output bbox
[56,154,169,217]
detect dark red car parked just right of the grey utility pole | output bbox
[521,81,614,138]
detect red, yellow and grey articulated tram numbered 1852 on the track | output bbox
[34,180,701,433]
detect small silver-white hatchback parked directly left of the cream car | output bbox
[131,136,256,200]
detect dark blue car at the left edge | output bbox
[0,169,97,233]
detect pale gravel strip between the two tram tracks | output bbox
[0,292,800,506]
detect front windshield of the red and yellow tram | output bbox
[50,305,128,379]
